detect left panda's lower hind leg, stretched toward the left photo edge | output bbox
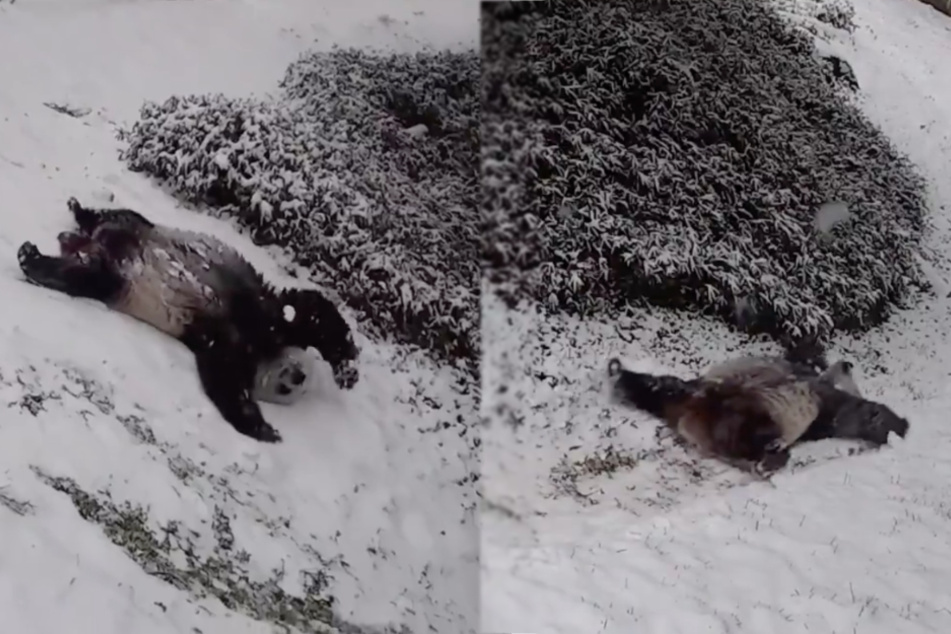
[17,242,124,302]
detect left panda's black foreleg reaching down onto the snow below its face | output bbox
[195,338,281,442]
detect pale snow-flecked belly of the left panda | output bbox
[112,245,221,338]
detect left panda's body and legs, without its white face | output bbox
[17,198,359,442]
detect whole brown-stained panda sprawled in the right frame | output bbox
[608,357,908,471]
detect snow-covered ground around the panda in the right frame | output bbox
[481,0,951,634]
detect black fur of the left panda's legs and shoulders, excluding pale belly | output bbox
[17,198,359,442]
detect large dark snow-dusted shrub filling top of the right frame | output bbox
[482,0,926,341]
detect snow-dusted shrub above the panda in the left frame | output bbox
[123,49,480,362]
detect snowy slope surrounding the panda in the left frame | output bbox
[0,0,478,634]
